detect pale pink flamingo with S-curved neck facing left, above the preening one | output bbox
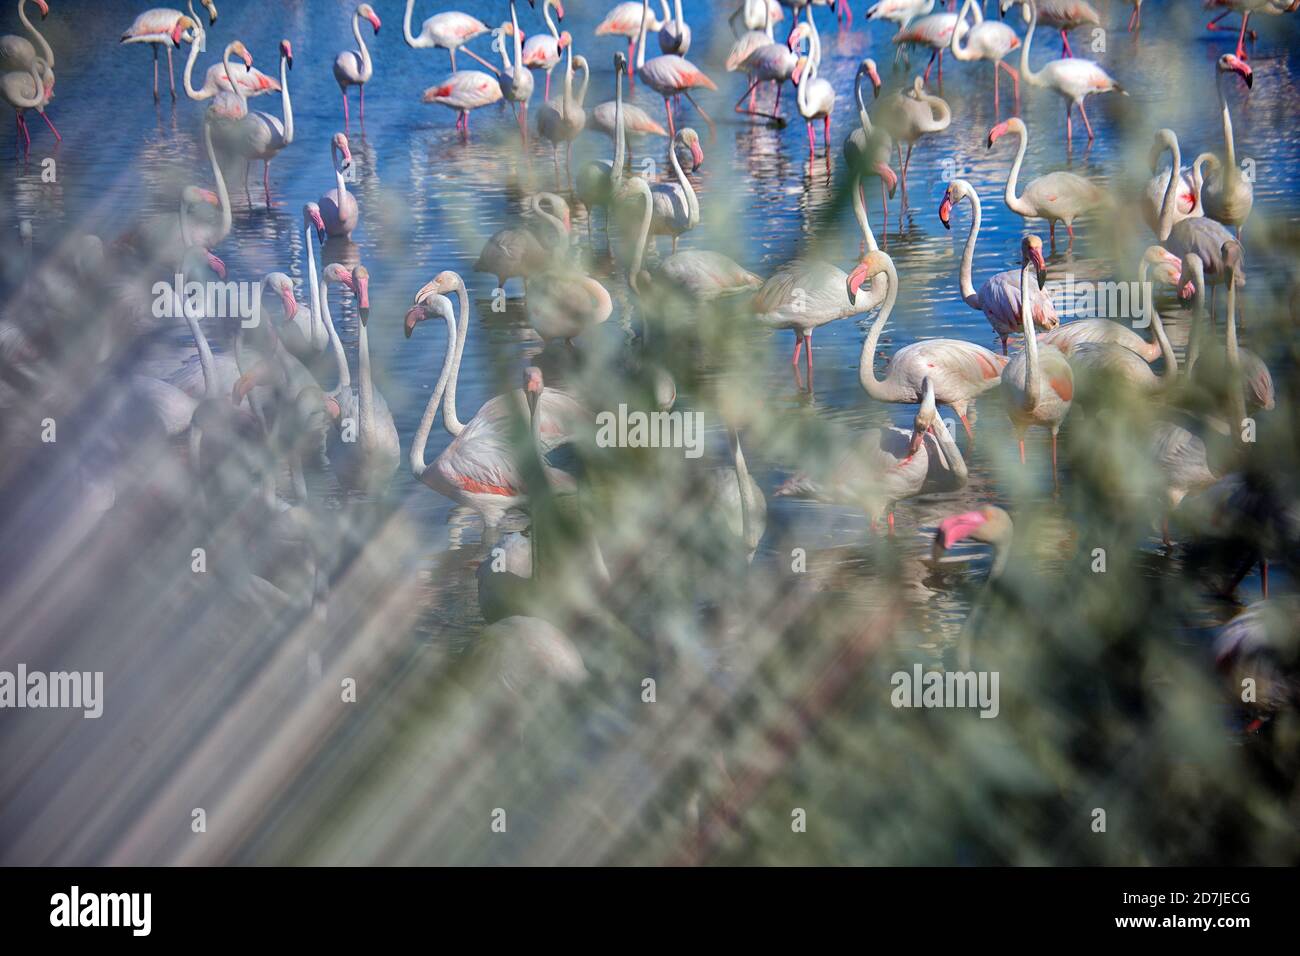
[848,250,1008,438]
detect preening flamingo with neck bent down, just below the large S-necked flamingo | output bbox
[772,378,969,535]
